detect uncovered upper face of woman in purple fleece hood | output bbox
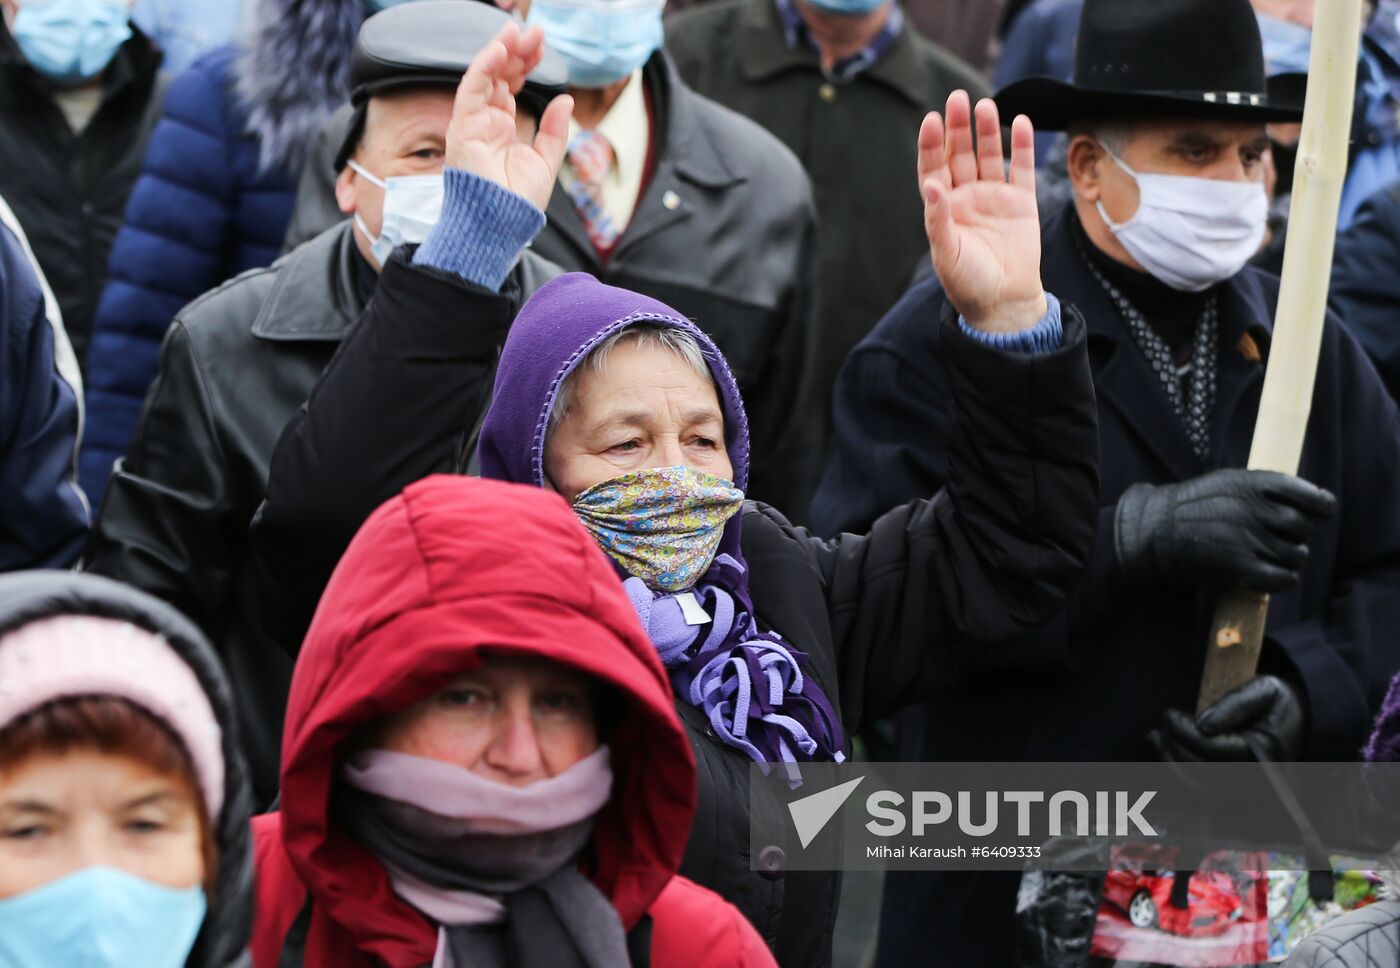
[545,342,734,502]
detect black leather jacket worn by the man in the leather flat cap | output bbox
[88,221,557,804]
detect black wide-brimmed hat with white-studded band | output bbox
[995,0,1302,130]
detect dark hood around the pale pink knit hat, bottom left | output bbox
[0,572,253,968]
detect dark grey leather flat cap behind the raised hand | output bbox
[336,0,568,171]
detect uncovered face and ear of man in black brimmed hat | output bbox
[1070,120,1268,269]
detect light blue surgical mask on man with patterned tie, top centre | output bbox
[525,0,665,88]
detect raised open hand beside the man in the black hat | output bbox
[918,91,1047,332]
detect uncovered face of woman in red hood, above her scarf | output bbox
[368,656,598,786]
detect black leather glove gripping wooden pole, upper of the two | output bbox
[1113,469,1337,591]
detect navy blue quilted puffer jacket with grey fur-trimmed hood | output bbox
[81,0,364,506]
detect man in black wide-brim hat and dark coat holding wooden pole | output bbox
[813,0,1400,968]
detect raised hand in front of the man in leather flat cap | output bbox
[445,22,574,210]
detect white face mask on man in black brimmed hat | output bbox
[1098,148,1268,293]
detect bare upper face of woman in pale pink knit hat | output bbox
[0,749,204,899]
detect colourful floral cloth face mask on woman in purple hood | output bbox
[574,466,743,591]
